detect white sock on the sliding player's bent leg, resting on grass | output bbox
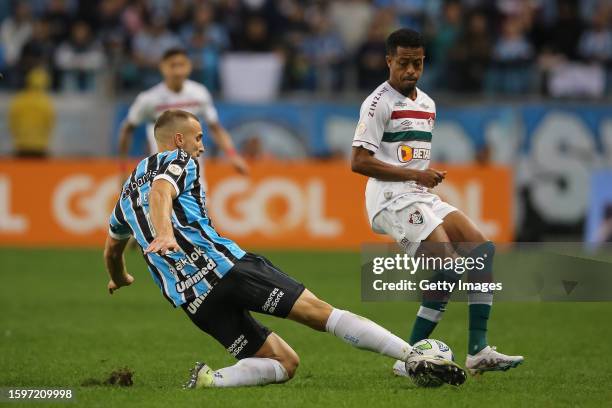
[213,357,289,387]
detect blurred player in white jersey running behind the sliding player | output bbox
[119,48,248,185]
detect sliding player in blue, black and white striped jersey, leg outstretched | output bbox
[104,110,465,388]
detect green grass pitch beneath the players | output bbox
[0,249,612,408]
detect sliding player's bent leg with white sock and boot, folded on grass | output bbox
[184,333,300,388]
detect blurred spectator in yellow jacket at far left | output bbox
[8,68,55,158]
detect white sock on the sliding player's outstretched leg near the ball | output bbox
[325,309,412,361]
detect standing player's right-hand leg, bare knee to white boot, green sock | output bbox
[443,211,523,374]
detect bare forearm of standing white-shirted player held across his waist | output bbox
[351,146,446,188]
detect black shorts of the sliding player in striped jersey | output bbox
[182,253,304,359]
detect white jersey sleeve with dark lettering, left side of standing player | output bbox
[353,95,391,153]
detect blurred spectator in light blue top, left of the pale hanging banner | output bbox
[488,17,534,94]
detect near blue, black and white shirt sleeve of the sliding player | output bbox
[153,149,200,196]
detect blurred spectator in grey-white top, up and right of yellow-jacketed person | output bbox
[55,21,104,91]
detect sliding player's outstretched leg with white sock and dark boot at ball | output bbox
[288,290,465,385]
